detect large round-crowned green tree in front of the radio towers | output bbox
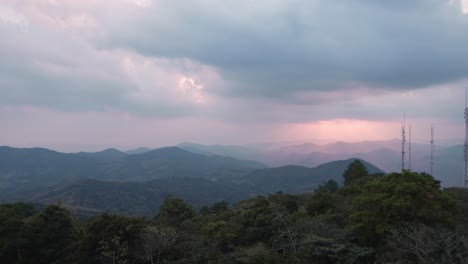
[350,171,456,243]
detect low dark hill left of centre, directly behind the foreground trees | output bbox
[30,178,249,217]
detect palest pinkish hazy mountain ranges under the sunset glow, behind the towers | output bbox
[179,139,464,187]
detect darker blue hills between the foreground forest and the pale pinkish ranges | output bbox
[0,142,383,215]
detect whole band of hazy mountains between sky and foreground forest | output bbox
[0,137,463,215]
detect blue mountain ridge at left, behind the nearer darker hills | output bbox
[0,147,265,196]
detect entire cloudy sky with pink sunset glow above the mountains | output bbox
[0,0,468,151]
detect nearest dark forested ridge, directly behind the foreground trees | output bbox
[15,160,382,216]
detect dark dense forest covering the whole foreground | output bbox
[0,161,468,264]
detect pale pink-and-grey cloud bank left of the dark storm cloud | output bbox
[0,2,208,117]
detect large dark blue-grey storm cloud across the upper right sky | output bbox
[105,0,468,100]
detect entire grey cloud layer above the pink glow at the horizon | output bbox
[0,0,468,126]
